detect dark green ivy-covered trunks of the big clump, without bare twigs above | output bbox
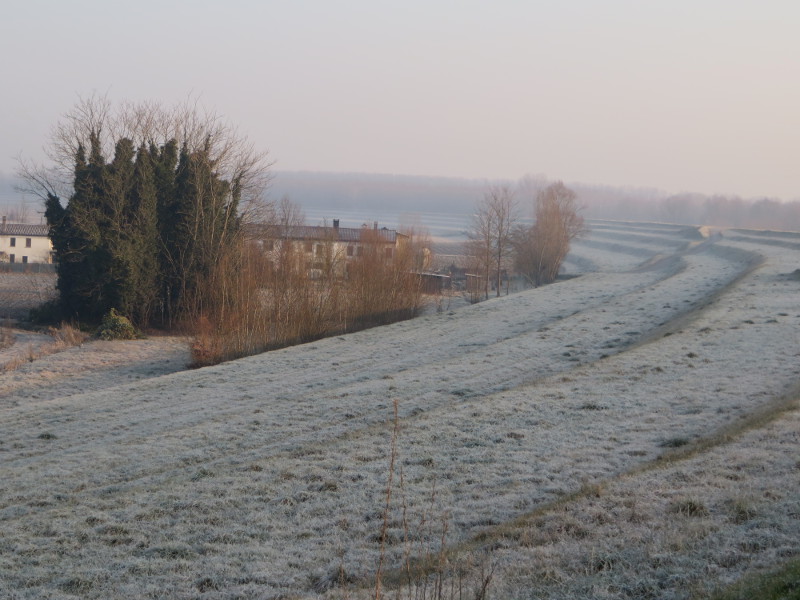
[46,134,241,326]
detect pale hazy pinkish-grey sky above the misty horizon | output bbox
[0,0,800,199]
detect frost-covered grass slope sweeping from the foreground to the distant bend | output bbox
[0,223,800,598]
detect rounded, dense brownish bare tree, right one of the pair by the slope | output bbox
[514,181,586,286]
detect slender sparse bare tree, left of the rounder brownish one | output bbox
[469,186,518,298]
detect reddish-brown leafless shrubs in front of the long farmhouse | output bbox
[191,218,422,366]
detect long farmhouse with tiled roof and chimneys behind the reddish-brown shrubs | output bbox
[253,219,408,277]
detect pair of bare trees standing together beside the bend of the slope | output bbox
[469,181,586,298]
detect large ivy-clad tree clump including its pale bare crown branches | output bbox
[22,97,269,327]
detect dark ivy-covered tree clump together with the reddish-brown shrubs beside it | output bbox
[22,97,420,365]
